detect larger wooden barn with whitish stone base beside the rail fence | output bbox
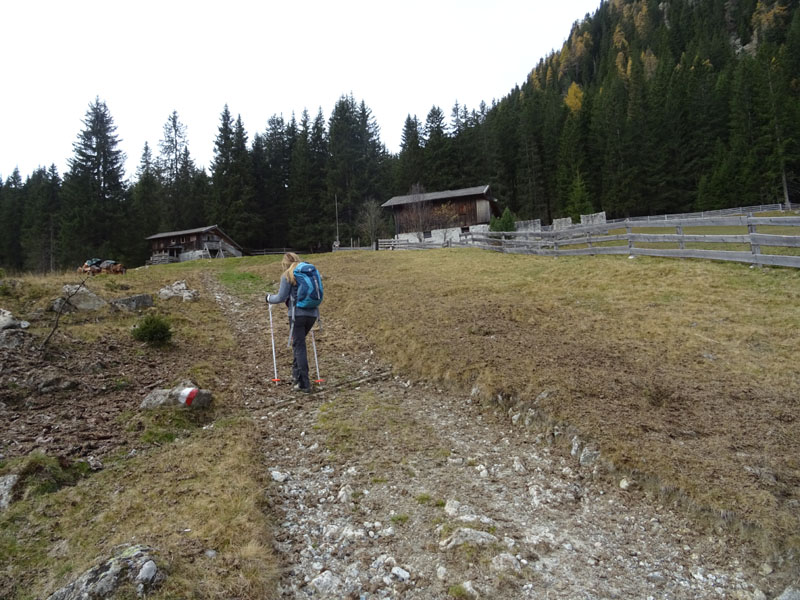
[381,185,500,234]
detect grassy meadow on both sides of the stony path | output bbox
[0,249,800,599]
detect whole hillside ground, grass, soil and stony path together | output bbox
[0,250,800,598]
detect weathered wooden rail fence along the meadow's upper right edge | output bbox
[452,216,800,268]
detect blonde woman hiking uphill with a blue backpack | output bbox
[266,252,322,394]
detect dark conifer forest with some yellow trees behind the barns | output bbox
[0,0,800,272]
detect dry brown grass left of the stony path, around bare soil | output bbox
[0,261,278,599]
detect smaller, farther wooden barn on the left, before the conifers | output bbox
[147,225,242,265]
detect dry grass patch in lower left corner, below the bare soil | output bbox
[3,419,278,598]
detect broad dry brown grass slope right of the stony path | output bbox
[308,250,800,549]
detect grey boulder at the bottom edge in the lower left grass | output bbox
[47,545,166,600]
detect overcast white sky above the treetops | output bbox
[0,0,600,180]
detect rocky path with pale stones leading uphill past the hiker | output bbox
[207,280,784,600]
